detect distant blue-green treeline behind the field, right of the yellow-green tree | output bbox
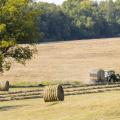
[33,0,120,41]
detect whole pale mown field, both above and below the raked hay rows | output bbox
[0,38,120,120]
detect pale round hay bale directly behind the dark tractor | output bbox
[90,69,105,83]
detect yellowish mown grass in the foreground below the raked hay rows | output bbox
[0,91,120,120]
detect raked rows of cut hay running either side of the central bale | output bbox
[0,83,120,101]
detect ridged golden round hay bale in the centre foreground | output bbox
[43,85,64,102]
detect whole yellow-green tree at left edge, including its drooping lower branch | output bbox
[0,0,39,72]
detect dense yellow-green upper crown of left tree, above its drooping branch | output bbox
[0,0,39,43]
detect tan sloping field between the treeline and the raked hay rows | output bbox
[0,38,120,82]
